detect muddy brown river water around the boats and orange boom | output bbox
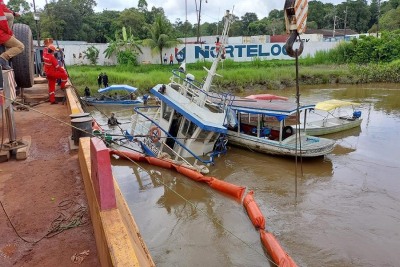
[89,84,400,267]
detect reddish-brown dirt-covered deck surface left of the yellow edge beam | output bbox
[0,99,100,267]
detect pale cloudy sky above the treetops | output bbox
[20,0,345,24]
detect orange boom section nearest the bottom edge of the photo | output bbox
[260,230,297,267]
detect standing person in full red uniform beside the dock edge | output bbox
[43,44,68,104]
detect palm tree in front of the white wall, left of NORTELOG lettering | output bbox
[143,15,181,64]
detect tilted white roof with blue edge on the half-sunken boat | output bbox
[150,84,228,133]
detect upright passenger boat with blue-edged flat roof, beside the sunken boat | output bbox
[220,98,335,157]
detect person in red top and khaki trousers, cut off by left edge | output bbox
[0,8,25,70]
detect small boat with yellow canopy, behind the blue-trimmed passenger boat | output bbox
[300,99,362,136]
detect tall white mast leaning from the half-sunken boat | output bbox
[198,10,233,107]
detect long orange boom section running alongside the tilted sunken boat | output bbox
[110,150,246,201]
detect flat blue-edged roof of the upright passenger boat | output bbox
[208,93,315,121]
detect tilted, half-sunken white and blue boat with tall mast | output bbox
[130,12,233,171]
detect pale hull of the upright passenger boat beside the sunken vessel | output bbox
[228,131,335,157]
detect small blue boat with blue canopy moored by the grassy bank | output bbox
[81,84,143,105]
